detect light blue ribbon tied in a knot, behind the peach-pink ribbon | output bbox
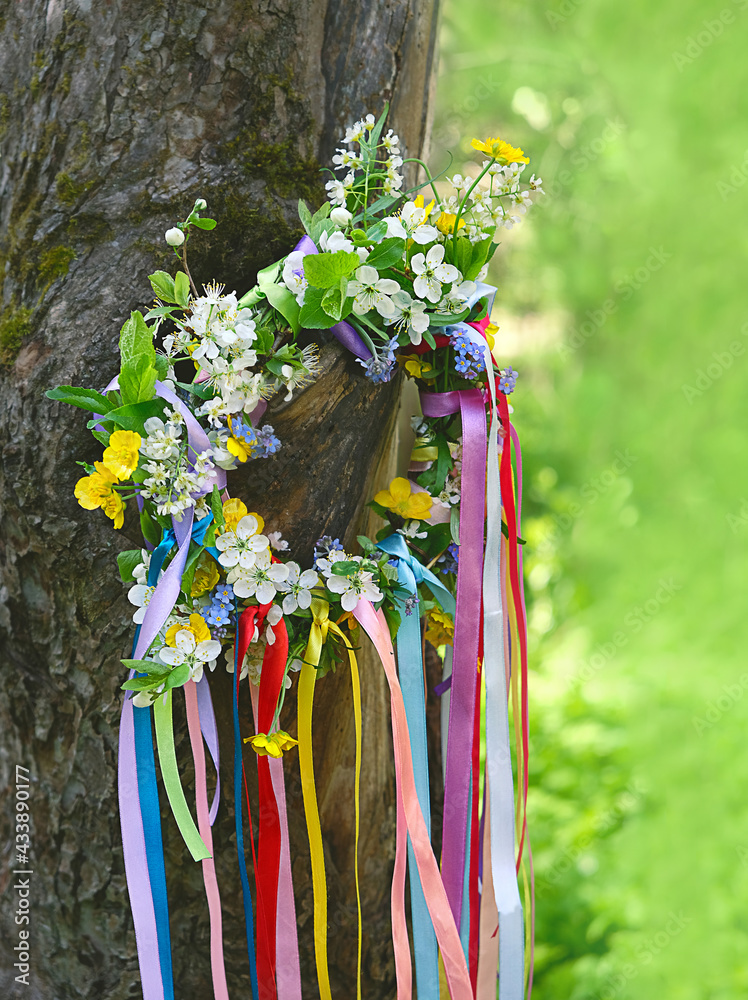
[377,533,455,997]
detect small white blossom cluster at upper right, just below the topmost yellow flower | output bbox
[444,160,544,243]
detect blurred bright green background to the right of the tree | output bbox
[431,0,748,1000]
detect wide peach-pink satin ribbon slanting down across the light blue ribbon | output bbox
[353,600,473,1000]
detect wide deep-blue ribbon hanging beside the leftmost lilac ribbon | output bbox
[131,514,218,1000]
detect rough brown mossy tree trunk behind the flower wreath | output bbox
[0,0,437,1000]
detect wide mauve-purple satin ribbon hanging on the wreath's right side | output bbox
[421,389,487,927]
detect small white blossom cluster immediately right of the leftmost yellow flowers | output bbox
[140,410,214,520]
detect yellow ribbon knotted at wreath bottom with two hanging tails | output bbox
[297,597,363,1000]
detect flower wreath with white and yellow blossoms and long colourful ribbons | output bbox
[47,109,542,1000]
